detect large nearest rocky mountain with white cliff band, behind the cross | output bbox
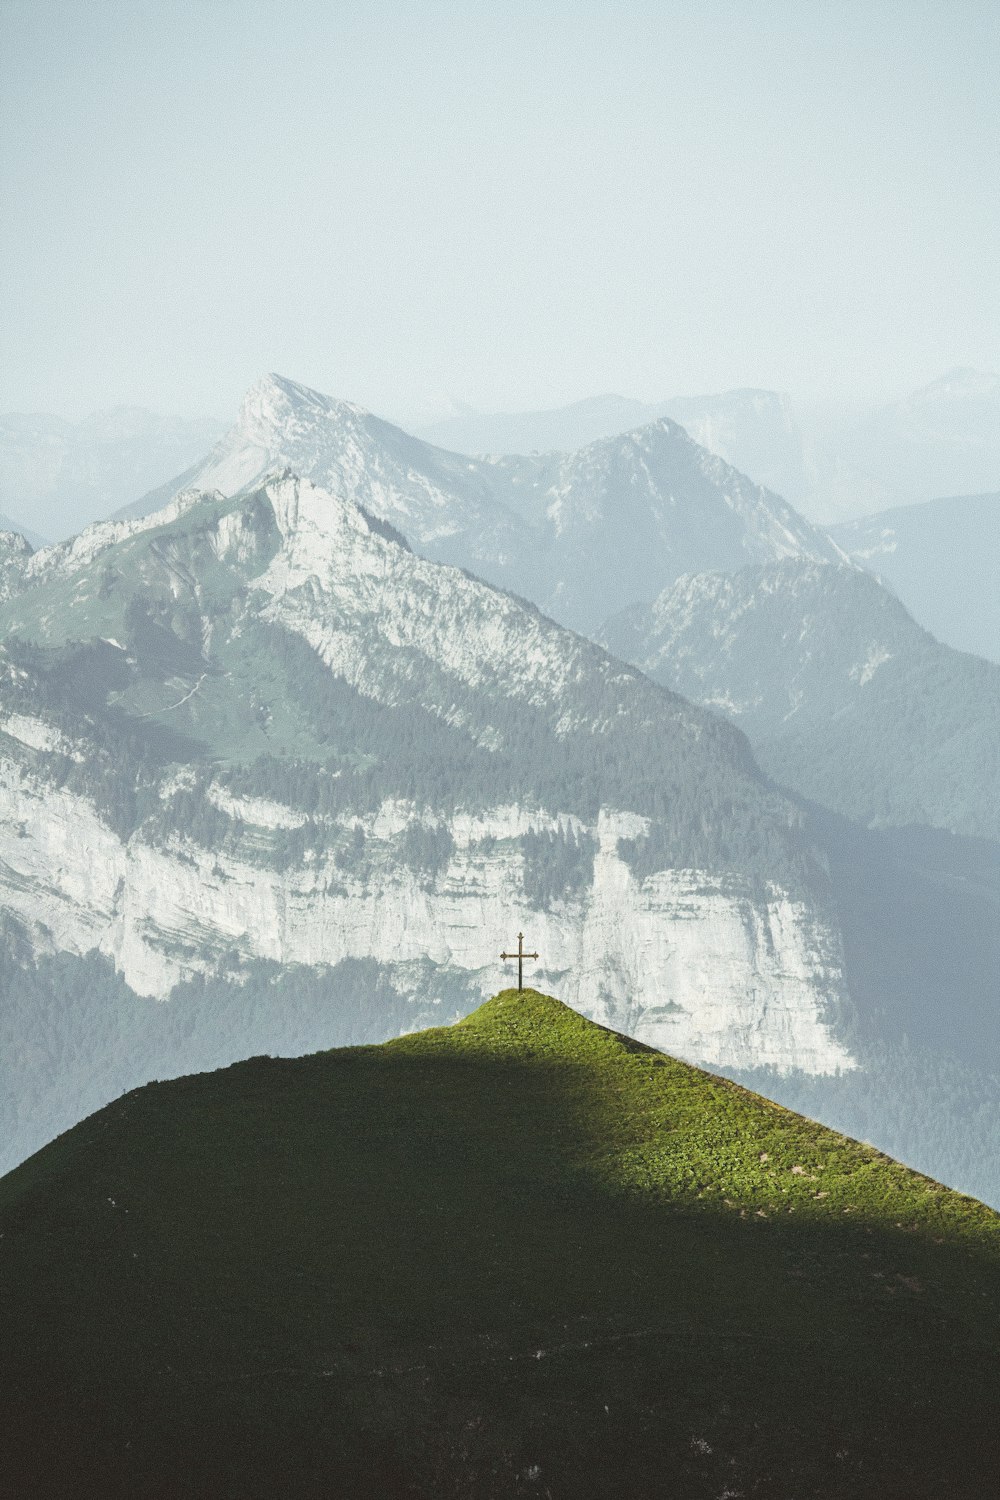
[0,476,853,1145]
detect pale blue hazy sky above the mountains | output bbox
[0,0,1000,416]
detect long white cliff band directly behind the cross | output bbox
[0,758,853,1074]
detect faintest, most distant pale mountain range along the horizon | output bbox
[0,369,1000,552]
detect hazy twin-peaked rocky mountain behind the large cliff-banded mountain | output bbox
[123,375,841,632]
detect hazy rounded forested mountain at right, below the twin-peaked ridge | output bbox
[603,560,1000,840]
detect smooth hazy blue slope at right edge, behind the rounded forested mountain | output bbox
[829,492,1000,662]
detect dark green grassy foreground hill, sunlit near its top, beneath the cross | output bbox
[0,990,1000,1500]
